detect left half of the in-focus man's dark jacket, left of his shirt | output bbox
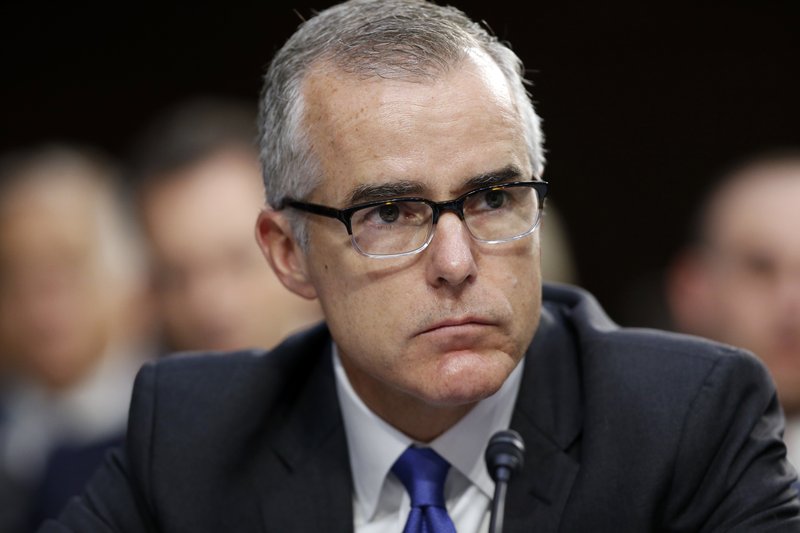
[48,325,352,532]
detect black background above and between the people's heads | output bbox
[0,0,800,325]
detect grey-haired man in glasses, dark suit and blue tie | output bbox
[45,0,800,533]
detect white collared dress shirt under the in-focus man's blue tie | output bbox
[333,346,523,533]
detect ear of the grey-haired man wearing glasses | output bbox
[256,208,317,300]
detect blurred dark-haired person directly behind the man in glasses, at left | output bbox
[132,99,321,353]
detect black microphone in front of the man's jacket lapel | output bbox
[484,429,525,533]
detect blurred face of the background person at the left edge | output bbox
[0,174,132,388]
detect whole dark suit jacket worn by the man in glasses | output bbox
[44,286,800,533]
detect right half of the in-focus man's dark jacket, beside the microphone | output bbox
[507,285,800,531]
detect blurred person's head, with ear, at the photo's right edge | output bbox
[666,151,800,466]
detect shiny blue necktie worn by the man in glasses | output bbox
[392,446,456,533]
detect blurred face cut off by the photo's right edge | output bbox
[707,166,800,413]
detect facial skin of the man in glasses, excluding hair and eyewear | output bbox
[258,48,541,441]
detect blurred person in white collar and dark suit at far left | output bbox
[0,146,152,533]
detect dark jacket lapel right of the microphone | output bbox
[504,308,581,533]
